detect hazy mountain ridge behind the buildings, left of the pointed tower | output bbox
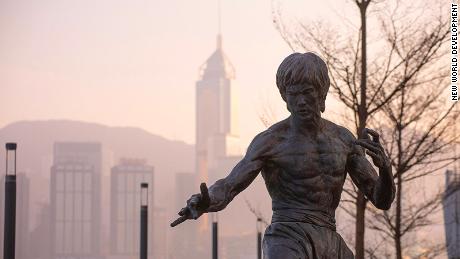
[0,120,194,223]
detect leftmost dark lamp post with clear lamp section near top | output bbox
[3,143,17,259]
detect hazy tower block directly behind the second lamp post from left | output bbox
[110,159,155,258]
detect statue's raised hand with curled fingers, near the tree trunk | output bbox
[356,128,391,169]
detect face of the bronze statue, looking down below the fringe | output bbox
[286,83,321,122]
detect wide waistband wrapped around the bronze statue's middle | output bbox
[272,209,336,231]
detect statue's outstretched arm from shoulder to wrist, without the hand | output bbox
[206,132,271,212]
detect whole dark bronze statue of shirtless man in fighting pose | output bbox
[171,53,395,259]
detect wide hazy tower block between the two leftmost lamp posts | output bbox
[50,142,102,259]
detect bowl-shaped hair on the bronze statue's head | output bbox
[276,52,330,112]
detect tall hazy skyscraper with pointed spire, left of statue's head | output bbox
[195,34,240,187]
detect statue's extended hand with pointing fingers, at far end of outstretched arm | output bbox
[171,183,211,227]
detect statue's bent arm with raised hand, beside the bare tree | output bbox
[347,129,395,210]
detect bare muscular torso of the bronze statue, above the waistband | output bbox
[262,122,350,217]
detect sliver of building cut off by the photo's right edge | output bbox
[442,170,460,258]
